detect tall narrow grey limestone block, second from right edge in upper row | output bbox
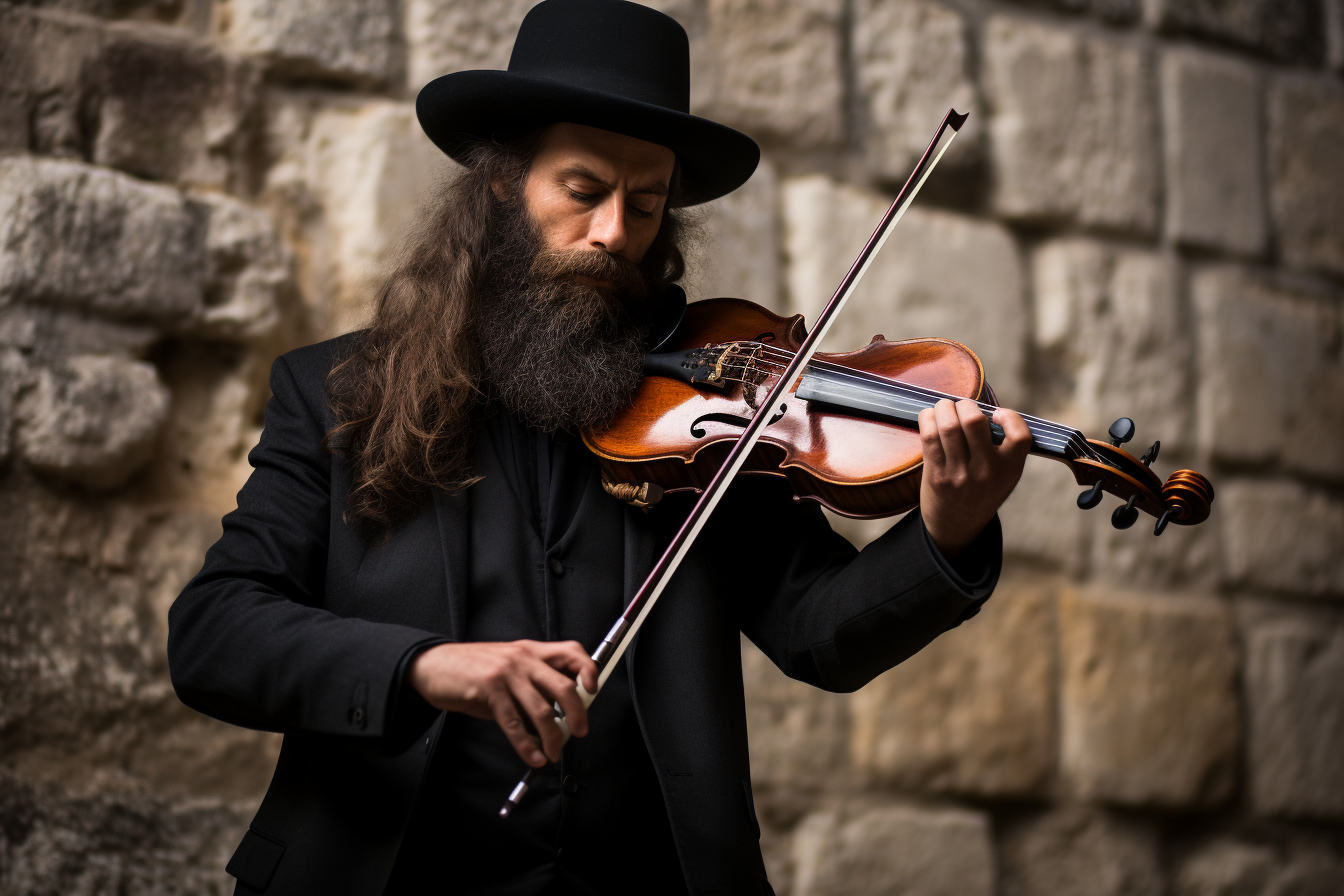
[1161,50,1266,255]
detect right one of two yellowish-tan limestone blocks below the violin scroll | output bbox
[1059,591,1241,807]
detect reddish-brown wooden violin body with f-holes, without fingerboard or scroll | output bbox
[585,298,989,519]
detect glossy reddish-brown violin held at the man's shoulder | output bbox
[585,298,1214,535]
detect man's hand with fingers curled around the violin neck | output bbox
[919,399,1031,559]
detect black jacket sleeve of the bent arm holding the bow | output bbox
[168,356,437,739]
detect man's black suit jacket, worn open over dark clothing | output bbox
[168,337,1000,895]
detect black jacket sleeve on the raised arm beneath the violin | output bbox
[719,478,1003,692]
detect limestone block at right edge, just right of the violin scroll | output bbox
[1214,481,1344,596]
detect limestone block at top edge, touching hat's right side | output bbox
[708,0,845,148]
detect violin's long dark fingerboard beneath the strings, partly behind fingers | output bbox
[797,364,1086,462]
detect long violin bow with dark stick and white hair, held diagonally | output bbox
[500,109,966,818]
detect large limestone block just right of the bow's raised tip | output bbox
[982,16,1160,234]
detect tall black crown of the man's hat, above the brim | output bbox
[508,0,691,113]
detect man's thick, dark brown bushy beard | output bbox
[476,201,649,433]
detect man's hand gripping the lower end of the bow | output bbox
[406,641,597,768]
